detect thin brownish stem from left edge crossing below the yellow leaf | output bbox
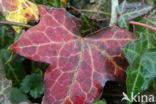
[0,21,32,28]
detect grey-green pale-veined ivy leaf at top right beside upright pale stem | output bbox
[117,0,152,21]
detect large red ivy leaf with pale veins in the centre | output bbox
[10,7,135,104]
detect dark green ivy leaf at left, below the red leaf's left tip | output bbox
[0,49,26,87]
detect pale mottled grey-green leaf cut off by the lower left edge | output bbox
[0,60,12,104]
